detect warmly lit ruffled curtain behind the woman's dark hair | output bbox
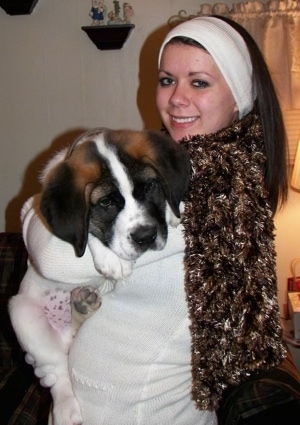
[168,0,300,161]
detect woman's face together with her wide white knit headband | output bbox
[157,18,254,140]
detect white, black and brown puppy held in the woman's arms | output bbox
[9,128,190,425]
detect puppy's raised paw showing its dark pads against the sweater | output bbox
[71,286,101,314]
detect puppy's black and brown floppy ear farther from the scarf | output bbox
[40,141,101,257]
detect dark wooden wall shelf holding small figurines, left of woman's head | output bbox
[81,24,135,50]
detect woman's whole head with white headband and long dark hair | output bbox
[157,16,288,212]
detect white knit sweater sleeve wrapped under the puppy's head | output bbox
[21,194,99,285]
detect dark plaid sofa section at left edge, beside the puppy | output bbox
[0,233,51,425]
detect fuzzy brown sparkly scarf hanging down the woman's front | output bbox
[181,114,285,410]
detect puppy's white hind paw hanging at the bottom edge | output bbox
[52,396,83,425]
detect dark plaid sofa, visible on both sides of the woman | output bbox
[0,233,300,425]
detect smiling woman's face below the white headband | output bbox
[156,44,238,141]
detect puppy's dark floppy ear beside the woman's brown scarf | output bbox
[143,131,191,218]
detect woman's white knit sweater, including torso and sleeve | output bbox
[23,195,217,425]
